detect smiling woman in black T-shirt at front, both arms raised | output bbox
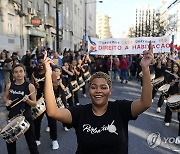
[44,43,153,154]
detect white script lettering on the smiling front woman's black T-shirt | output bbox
[83,120,118,135]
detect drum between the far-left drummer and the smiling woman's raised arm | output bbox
[31,97,46,119]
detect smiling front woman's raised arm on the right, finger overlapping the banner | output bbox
[131,42,154,117]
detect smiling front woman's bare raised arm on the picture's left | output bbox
[44,52,72,124]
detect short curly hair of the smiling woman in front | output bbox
[89,72,112,88]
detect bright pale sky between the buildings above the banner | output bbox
[97,0,162,38]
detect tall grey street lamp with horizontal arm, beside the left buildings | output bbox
[83,0,103,52]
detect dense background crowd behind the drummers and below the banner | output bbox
[0,49,179,97]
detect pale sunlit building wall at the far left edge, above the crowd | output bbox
[0,0,22,53]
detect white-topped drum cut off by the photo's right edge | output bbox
[167,94,180,112]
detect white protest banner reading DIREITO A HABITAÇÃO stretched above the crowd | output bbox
[88,36,170,55]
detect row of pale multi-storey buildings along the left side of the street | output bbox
[0,0,96,55]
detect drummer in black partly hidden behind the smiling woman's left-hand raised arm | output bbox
[31,53,59,150]
